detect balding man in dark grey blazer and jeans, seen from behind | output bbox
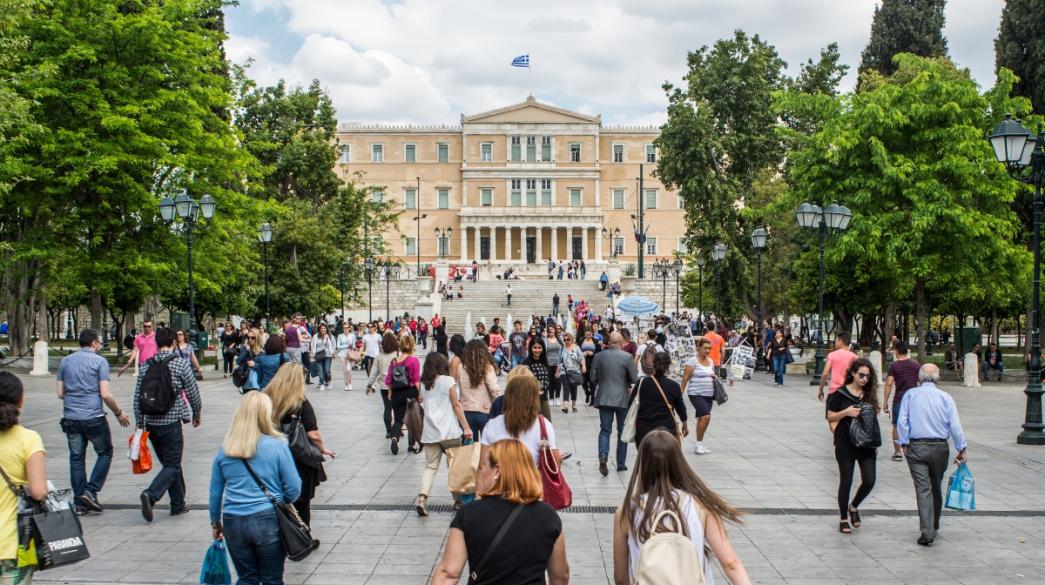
[588,331,636,476]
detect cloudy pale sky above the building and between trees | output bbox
[226,0,1003,124]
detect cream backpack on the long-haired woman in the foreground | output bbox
[633,510,706,585]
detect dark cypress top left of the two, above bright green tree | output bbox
[860,0,947,76]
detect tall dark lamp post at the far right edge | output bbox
[991,114,1045,445]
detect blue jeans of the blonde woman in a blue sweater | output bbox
[222,510,286,585]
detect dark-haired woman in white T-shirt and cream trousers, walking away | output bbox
[415,352,472,516]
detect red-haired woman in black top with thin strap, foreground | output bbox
[432,438,570,585]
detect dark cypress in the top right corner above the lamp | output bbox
[994,0,1045,114]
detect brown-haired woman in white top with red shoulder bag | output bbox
[479,374,562,468]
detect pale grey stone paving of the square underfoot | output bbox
[10,359,1045,585]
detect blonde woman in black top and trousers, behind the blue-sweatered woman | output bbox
[264,362,338,525]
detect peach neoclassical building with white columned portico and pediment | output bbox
[338,96,684,274]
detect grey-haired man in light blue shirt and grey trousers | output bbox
[897,364,968,546]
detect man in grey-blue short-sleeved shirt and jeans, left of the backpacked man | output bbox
[57,329,131,514]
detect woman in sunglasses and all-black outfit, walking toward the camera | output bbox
[828,357,880,534]
